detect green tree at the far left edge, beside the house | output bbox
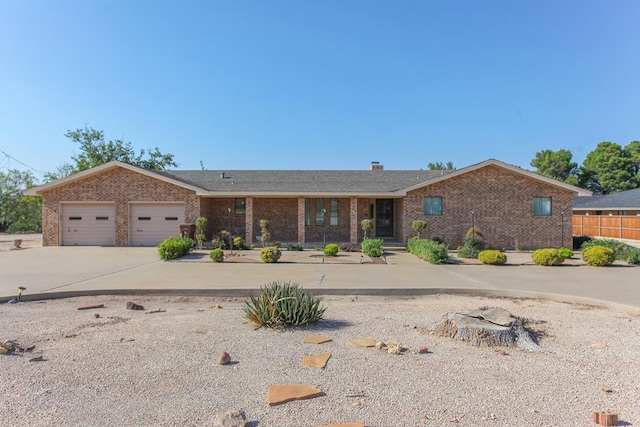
[0,169,42,233]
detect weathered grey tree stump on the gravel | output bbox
[430,307,549,353]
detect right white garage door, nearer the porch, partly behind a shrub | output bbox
[129,203,184,246]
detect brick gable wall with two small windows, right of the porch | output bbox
[402,166,573,250]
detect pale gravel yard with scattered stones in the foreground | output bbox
[0,295,640,427]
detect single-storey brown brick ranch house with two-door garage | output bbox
[25,159,591,249]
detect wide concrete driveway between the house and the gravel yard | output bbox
[0,247,640,311]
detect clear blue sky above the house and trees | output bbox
[0,0,640,176]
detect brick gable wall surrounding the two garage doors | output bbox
[42,167,200,246]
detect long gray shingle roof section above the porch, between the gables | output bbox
[156,170,451,194]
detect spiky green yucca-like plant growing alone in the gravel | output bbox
[243,282,326,328]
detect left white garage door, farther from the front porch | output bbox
[60,203,116,246]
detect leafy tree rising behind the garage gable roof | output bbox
[46,127,178,180]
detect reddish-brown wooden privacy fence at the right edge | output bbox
[573,215,640,240]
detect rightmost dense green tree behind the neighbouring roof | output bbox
[579,141,639,194]
